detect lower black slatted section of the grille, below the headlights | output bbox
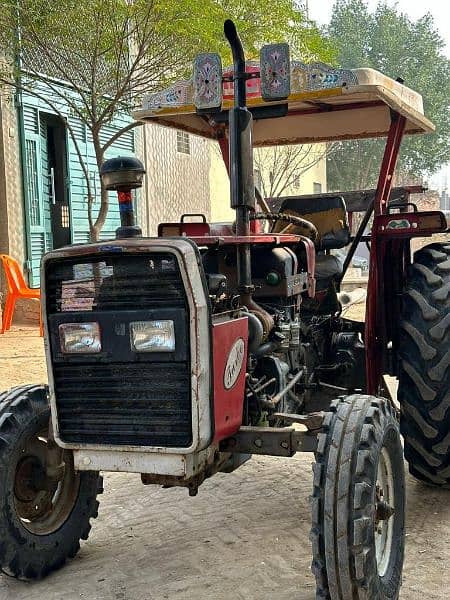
[54,363,192,448]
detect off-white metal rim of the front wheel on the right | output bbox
[375,448,395,577]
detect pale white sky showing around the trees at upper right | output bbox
[303,0,450,190]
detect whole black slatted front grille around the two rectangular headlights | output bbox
[46,254,192,447]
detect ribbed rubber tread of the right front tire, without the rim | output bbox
[310,394,403,600]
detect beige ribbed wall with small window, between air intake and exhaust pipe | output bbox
[138,123,211,236]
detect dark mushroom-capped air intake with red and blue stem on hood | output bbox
[100,156,145,239]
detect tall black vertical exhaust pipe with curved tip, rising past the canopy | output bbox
[224,20,255,295]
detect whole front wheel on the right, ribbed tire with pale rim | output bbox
[311,395,405,600]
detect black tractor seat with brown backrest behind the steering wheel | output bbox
[273,196,350,250]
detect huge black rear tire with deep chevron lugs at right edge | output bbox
[398,243,450,488]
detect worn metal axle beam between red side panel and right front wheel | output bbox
[220,427,317,456]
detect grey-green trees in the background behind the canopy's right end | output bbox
[328,0,450,190]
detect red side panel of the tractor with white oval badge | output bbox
[212,317,248,442]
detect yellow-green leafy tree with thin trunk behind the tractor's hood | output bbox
[0,0,333,238]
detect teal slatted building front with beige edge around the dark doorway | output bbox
[0,84,135,287]
